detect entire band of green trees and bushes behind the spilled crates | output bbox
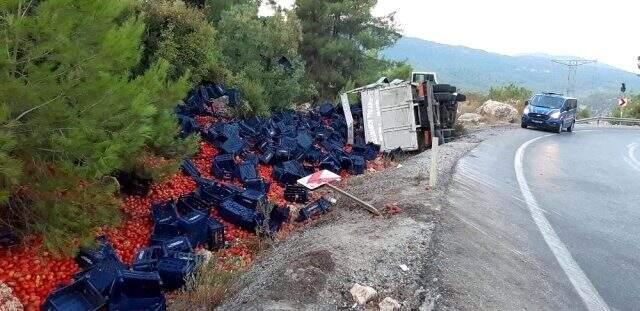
[0,0,411,253]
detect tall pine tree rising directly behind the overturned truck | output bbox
[294,0,400,99]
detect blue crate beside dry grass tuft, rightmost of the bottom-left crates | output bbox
[158,253,197,290]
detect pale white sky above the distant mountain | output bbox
[262,0,640,73]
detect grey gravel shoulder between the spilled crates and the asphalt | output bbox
[219,126,513,310]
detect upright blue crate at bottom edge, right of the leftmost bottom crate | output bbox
[109,271,166,311]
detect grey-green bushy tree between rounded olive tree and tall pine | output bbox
[218,3,314,115]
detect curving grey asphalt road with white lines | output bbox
[438,127,640,310]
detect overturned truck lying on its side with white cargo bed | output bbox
[341,74,466,151]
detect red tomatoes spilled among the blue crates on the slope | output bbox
[0,117,388,310]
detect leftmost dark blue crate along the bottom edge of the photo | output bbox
[42,279,106,311]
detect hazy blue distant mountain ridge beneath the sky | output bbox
[383,37,640,97]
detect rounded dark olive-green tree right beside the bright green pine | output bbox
[138,0,218,84]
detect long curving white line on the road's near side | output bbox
[513,134,609,311]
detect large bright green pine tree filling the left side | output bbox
[0,0,192,251]
